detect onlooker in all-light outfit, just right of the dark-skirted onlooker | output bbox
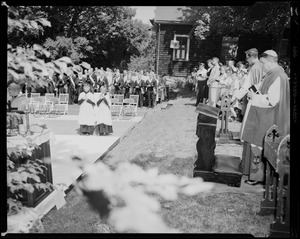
[207,57,220,107]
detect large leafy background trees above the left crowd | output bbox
[9,6,155,69]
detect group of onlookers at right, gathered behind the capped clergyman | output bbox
[188,48,289,122]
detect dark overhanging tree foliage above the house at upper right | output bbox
[183,2,290,39]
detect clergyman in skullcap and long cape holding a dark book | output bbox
[241,50,290,184]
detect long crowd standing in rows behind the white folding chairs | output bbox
[23,67,168,108]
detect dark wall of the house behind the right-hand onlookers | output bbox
[157,24,274,77]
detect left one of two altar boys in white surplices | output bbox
[78,81,95,135]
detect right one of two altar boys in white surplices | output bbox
[95,85,113,135]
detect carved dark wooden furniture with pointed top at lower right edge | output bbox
[259,125,290,237]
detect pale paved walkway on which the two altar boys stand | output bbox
[34,105,147,218]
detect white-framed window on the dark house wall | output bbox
[173,34,190,61]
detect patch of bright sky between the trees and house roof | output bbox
[154,6,193,23]
